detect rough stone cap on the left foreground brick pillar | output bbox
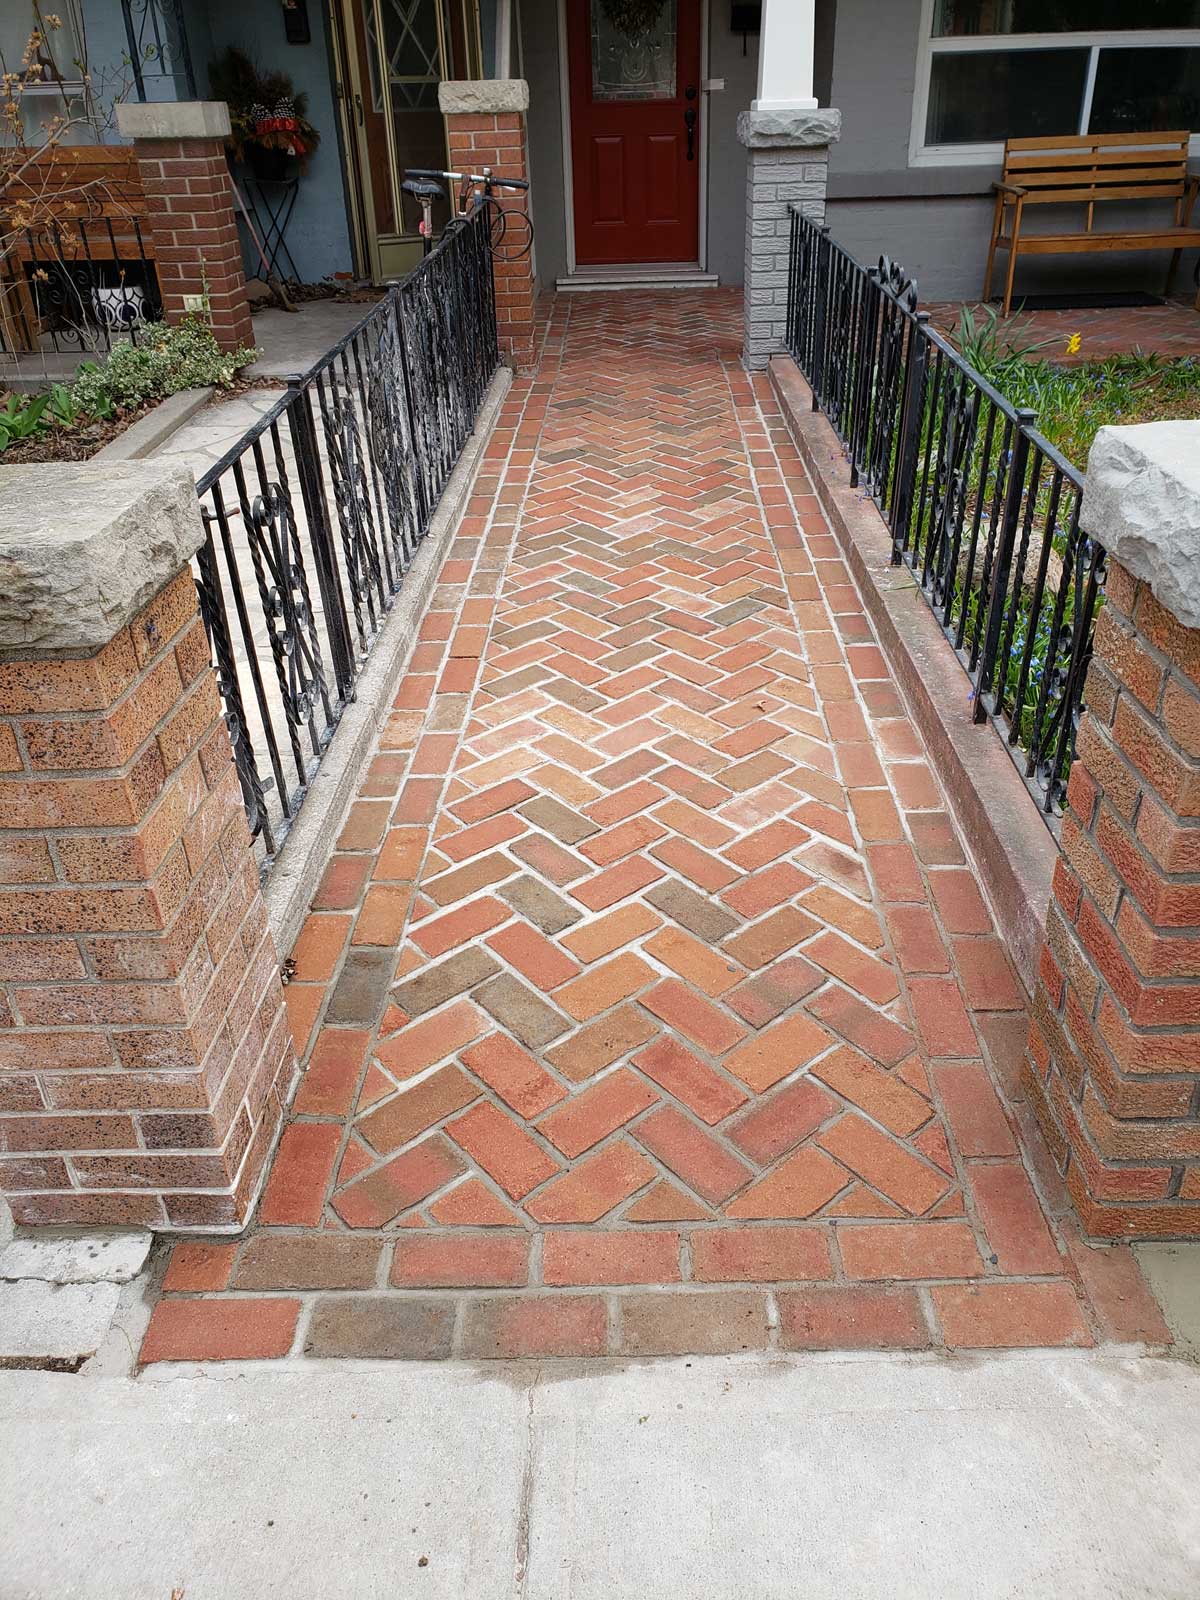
[0,461,205,656]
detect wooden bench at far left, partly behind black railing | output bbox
[0,144,155,352]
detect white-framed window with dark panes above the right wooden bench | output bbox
[910,0,1200,166]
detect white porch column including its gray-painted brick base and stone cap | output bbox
[738,0,842,368]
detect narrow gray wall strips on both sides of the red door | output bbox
[518,0,758,286]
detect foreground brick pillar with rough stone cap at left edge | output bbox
[0,461,294,1229]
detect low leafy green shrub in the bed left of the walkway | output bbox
[72,317,258,416]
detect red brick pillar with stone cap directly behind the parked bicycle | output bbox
[437,78,534,371]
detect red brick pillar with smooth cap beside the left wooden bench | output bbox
[117,101,254,350]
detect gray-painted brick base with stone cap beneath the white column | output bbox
[738,107,842,371]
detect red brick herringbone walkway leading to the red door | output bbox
[142,291,1166,1362]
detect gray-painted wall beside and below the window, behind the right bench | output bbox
[826,0,1197,301]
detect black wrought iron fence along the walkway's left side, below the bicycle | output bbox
[197,213,499,866]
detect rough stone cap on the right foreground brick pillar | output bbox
[1080,422,1200,627]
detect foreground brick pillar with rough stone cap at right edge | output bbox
[1024,422,1200,1238]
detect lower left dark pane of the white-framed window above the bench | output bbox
[925,50,1088,144]
